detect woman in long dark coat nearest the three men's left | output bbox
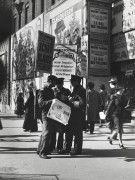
[23,91,38,132]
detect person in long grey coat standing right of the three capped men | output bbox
[87,82,101,134]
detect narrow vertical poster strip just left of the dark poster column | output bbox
[81,35,88,78]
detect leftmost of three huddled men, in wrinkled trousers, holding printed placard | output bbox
[37,75,57,159]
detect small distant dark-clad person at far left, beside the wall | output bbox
[16,92,24,118]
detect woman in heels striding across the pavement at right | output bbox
[106,78,125,149]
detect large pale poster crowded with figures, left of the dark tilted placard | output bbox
[11,15,43,80]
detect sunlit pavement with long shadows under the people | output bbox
[0,113,135,180]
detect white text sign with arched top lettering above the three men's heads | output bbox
[52,45,77,80]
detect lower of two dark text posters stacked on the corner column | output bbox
[89,35,109,75]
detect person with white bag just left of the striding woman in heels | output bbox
[99,84,107,127]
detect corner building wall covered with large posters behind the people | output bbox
[2,0,111,111]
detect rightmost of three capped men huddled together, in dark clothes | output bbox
[63,75,86,155]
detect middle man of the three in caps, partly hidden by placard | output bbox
[50,78,71,153]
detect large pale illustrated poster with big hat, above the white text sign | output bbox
[51,2,82,47]
